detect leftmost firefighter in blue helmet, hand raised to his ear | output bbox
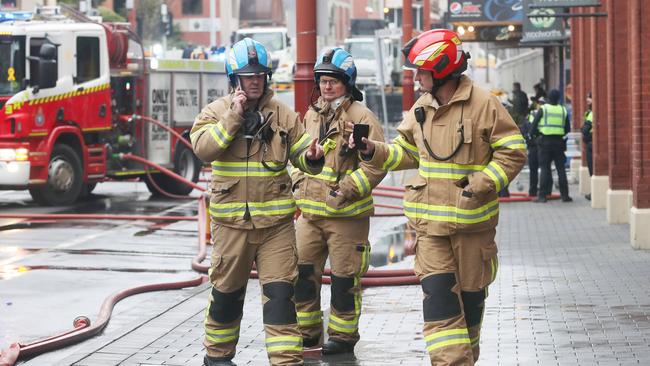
[190,38,324,366]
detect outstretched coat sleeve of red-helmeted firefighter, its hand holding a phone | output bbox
[368,119,420,171]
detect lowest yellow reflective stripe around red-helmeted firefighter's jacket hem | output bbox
[404,200,499,224]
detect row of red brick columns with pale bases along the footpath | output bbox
[570,0,650,249]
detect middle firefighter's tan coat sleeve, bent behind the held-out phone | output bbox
[339,111,386,200]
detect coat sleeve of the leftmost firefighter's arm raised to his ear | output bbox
[190,99,243,162]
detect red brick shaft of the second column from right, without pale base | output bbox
[596,0,632,190]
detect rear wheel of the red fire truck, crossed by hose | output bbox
[145,144,202,196]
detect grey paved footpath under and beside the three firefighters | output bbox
[26,187,650,366]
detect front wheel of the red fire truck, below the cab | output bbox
[29,144,83,206]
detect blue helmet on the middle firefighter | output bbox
[314,47,363,101]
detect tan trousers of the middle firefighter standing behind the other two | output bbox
[296,216,370,346]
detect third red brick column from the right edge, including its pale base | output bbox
[588,5,609,208]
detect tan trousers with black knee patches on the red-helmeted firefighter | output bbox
[415,229,498,366]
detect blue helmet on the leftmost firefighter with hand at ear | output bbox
[226,37,271,85]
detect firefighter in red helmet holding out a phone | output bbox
[350,29,526,366]
